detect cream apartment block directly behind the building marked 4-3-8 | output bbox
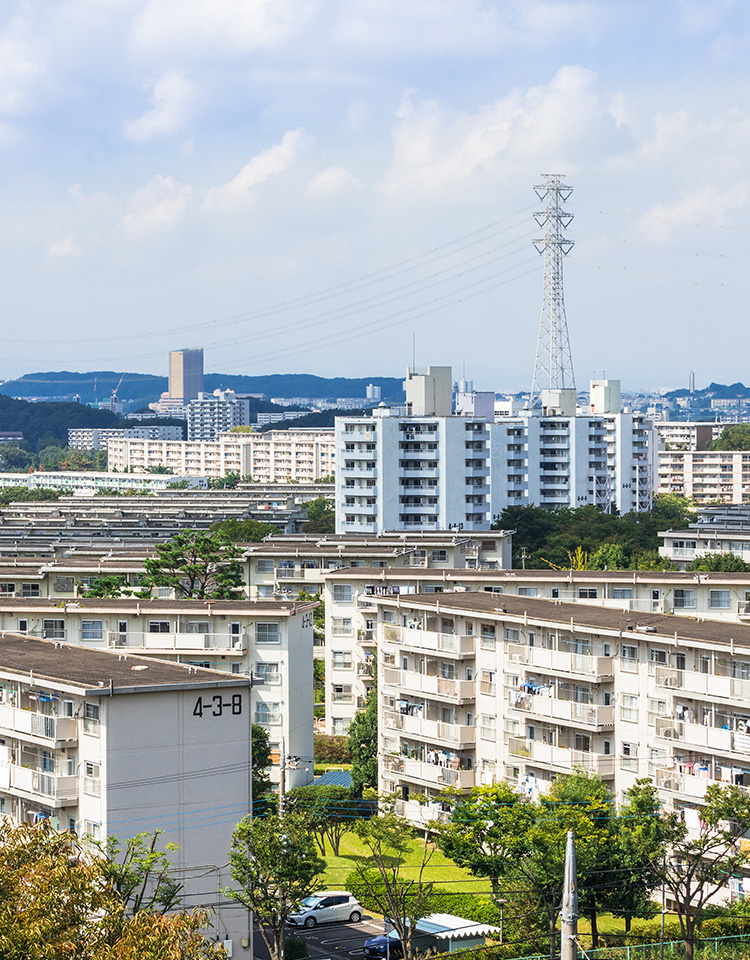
[0,596,316,788]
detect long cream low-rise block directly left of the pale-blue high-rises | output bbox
[107,430,334,483]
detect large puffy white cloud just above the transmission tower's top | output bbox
[387,66,614,192]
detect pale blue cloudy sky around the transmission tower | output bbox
[0,0,750,391]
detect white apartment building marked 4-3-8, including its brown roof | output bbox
[0,633,252,957]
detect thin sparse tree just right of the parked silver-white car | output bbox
[352,811,434,960]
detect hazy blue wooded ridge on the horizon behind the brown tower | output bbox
[0,370,403,410]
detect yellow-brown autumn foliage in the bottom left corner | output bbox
[0,818,225,960]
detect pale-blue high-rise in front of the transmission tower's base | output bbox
[489,380,654,516]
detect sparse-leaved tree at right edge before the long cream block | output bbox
[659,783,750,960]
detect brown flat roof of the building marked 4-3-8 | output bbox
[0,633,250,696]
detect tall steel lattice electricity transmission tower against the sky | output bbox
[531,173,576,406]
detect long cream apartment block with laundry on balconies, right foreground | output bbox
[372,593,750,840]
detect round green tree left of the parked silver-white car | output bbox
[223,812,325,960]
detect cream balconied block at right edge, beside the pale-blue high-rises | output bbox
[657,450,750,504]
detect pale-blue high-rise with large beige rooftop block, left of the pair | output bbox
[336,367,491,533]
